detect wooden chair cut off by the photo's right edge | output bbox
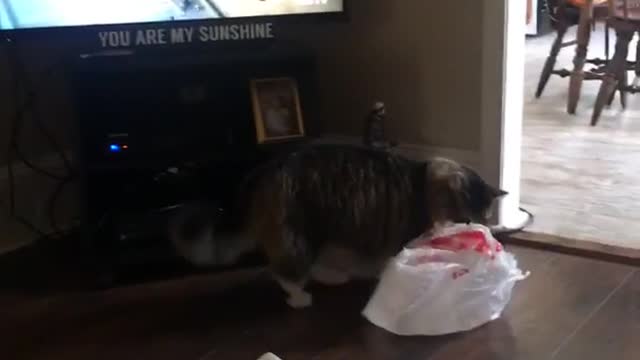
[591,0,640,126]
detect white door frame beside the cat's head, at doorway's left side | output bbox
[480,0,528,228]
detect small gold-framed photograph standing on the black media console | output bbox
[251,77,305,144]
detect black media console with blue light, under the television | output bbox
[69,47,318,286]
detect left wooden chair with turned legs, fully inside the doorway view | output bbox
[535,0,609,114]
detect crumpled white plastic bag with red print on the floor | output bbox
[363,224,529,335]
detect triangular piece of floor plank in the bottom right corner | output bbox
[555,271,640,360]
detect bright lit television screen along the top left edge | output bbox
[0,0,344,30]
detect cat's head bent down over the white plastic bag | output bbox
[430,159,508,225]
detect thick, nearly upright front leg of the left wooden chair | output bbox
[567,6,591,114]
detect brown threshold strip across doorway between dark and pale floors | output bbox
[499,231,640,266]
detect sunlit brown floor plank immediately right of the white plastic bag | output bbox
[420,255,633,360]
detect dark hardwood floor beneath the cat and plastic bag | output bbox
[0,242,640,360]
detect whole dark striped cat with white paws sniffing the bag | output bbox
[171,145,505,307]
